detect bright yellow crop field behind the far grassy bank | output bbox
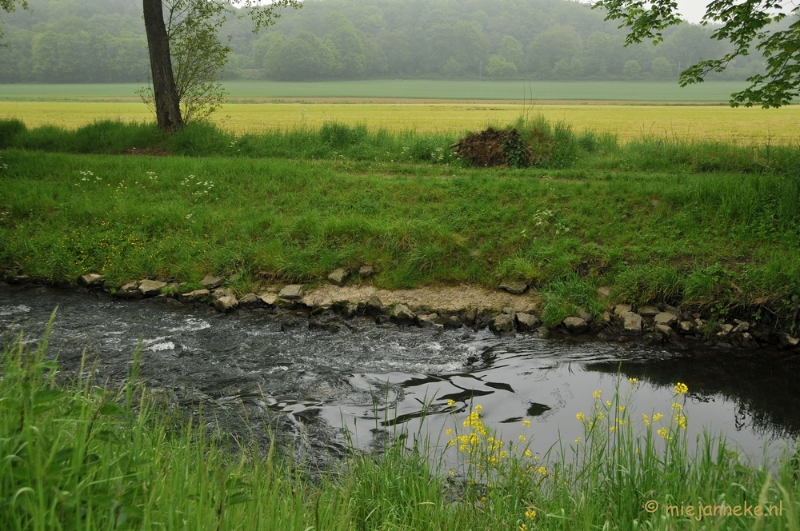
[0,101,800,144]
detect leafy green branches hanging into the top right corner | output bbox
[592,0,800,108]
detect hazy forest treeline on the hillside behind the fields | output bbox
[0,0,764,83]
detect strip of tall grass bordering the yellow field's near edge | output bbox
[0,114,800,177]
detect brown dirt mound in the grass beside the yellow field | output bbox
[451,127,532,167]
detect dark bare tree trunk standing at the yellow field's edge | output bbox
[142,0,184,132]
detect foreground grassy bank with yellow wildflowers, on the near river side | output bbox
[0,318,800,531]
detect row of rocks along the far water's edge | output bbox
[4,266,800,350]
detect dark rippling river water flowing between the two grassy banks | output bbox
[0,286,800,460]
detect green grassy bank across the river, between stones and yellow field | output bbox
[0,118,800,328]
